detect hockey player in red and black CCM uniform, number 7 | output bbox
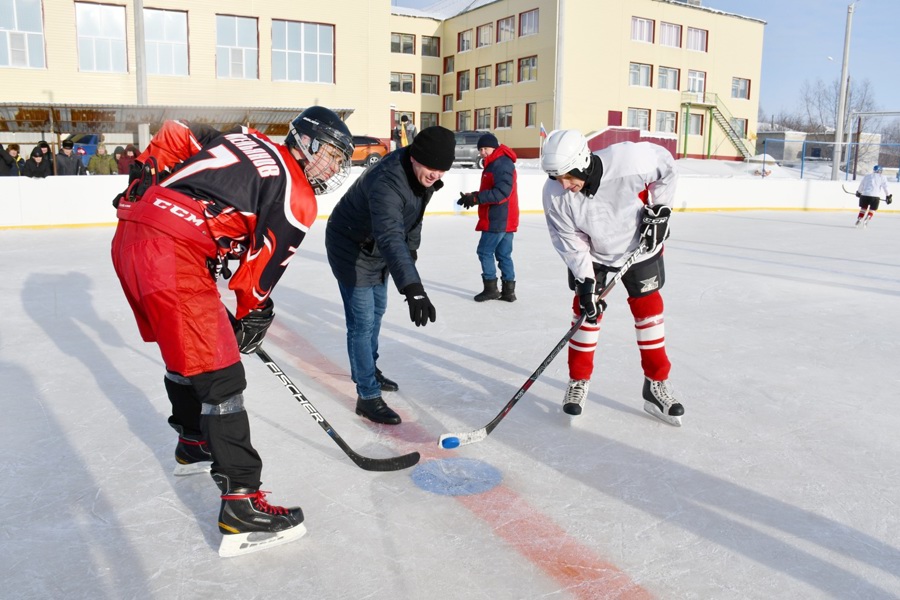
[112,106,353,556]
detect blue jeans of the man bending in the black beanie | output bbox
[338,280,387,400]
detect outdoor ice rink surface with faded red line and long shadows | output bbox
[0,209,900,600]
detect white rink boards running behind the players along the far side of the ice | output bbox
[0,166,880,228]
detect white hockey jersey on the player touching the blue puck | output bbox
[543,142,678,281]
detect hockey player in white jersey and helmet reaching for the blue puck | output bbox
[541,129,684,426]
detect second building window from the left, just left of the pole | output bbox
[75,2,128,73]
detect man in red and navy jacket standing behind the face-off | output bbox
[457,133,519,302]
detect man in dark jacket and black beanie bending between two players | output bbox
[325,126,456,425]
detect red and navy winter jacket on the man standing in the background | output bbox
[475,144,519,232]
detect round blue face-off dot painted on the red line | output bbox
[411,458,503,496]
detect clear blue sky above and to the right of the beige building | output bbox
[392,0,900,116]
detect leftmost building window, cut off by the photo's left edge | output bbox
[0,0,44,69]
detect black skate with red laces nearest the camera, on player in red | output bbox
[214,476,306,557]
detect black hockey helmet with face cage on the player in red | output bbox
[285,106,353,194]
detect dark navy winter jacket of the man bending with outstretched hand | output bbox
[325,148,444,292]
